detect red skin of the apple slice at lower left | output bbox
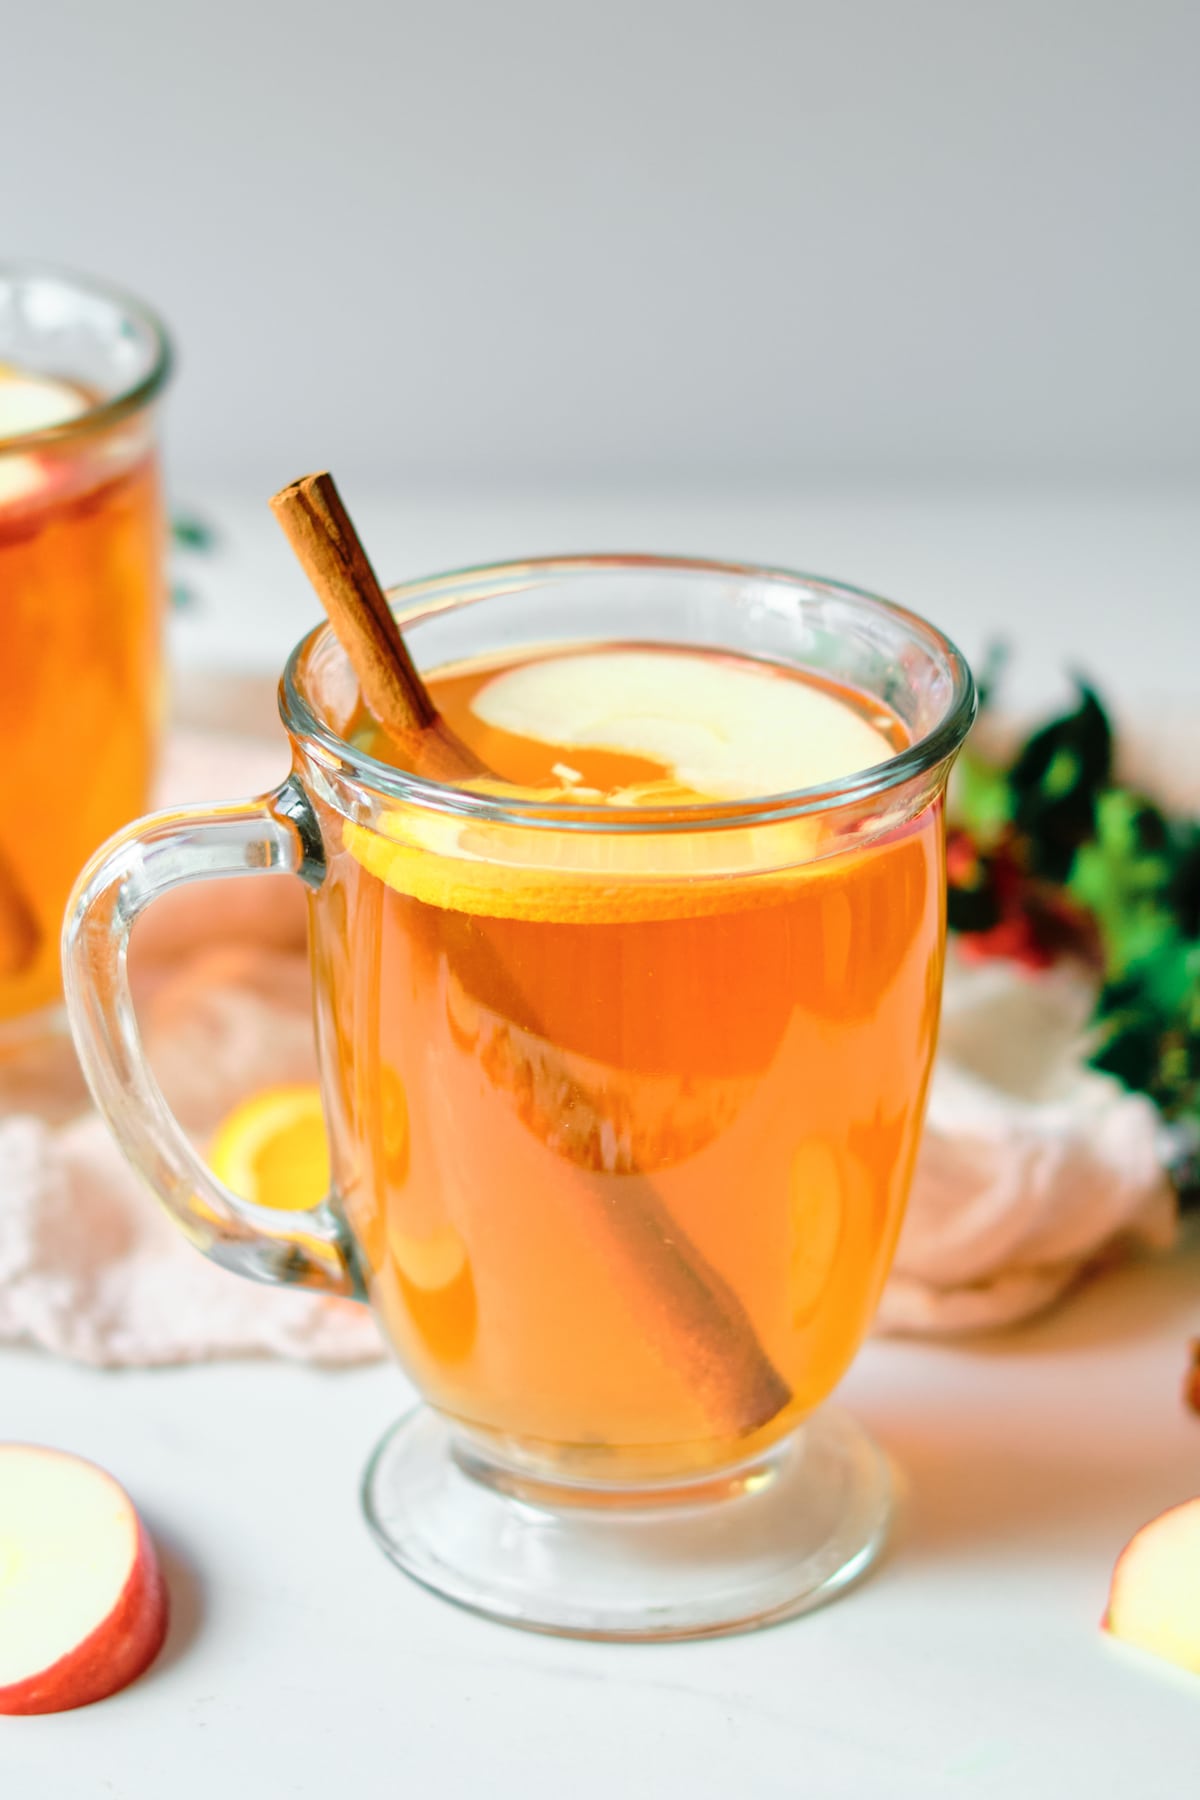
[0,1519,169,1714]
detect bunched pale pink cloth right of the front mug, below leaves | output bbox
[878,952,1177,1332]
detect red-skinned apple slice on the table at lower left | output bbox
[0,1444,167,1714]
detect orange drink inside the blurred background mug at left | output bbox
[0,369,162,1019]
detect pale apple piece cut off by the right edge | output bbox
[1103,1499,1200,1674]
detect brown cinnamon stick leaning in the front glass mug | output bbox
[270,473,792,1435]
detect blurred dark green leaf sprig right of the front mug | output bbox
[948,680,1200,1136]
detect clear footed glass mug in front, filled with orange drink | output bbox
[65,556,975,1638]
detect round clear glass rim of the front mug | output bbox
[279,553,977,833]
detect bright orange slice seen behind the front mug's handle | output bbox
[209,1084,329,1211]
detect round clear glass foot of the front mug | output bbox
[363,1408,892,1642]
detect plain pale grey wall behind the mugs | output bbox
[0,0,1200,491]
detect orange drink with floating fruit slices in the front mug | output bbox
[313,646,943,1481]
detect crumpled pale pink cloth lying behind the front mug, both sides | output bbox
[0,733,1175,1364]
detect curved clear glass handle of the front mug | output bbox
[63,776,363,1300]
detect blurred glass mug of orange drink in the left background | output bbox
[0,265,169,1026]
